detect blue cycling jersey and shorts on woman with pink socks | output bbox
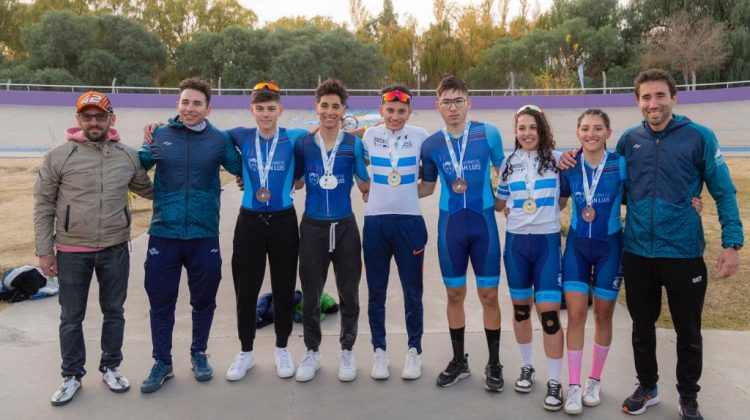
[560,153,627,300]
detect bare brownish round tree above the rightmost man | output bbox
[645,12,728,84]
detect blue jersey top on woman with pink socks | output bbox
[560,153,627,241]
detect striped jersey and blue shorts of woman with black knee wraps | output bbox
[497,149,562,303]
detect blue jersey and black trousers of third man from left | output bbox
[228,127,308,352]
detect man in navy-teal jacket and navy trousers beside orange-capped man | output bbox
[138,79,242,393]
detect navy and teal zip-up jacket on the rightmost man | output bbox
[617,115,743,258]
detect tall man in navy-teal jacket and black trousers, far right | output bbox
[617,70,744,419]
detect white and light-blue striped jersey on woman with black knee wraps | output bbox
[496,149,561,234]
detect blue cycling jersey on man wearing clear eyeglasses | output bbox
[422,122,505,214]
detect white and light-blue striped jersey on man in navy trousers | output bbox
[362,125,429,216]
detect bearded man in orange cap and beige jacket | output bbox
[34,92,153,406]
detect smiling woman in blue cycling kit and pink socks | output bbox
[560,109,627,414]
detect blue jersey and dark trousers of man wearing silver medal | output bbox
[294,133,369,351]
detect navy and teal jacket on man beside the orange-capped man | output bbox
[138,117,242,239]
